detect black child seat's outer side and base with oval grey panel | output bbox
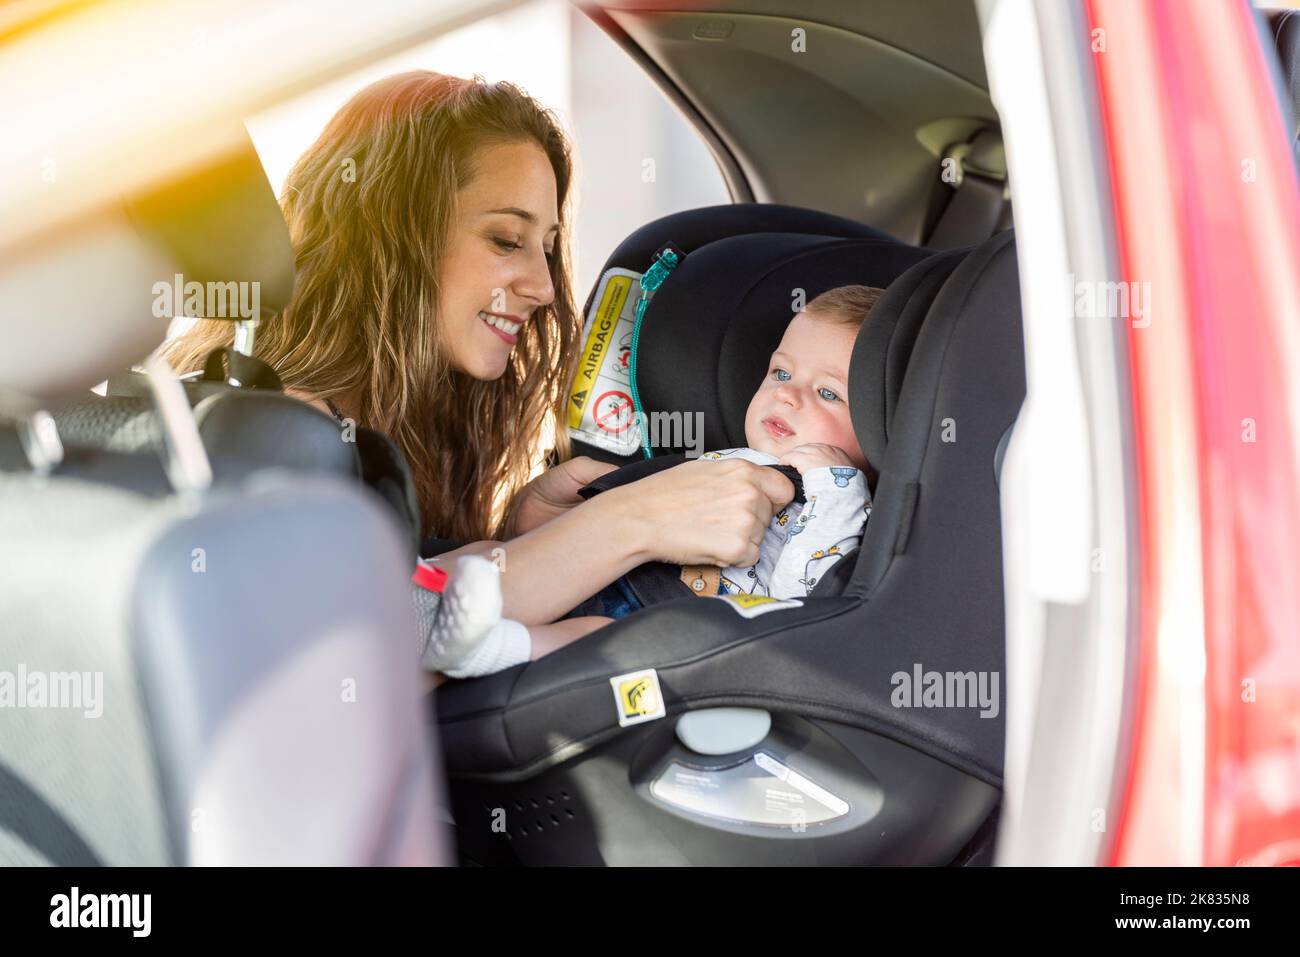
[436,221,1024,863]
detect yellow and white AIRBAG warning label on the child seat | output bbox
[568,269,642,455]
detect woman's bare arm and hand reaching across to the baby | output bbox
[436,460,794,625]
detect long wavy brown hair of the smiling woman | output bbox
[168,70,581,540]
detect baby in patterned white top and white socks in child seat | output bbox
[413,286,881,677]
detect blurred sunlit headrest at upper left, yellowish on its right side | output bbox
[0,123,294,415]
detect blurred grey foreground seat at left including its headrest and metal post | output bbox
[0,128,447,865]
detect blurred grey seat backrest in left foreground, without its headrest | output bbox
[0,459,443,866]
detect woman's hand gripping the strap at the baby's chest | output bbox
[605,459,794,567]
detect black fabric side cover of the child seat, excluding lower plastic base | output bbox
[436,234,1024,787]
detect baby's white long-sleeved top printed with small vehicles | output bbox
[701,449,871,598]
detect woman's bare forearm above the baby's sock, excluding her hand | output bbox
[437,489,653,625]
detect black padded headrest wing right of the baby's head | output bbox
[849,250,967,468]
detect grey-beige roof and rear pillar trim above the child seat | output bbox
[590,0,997,243]
